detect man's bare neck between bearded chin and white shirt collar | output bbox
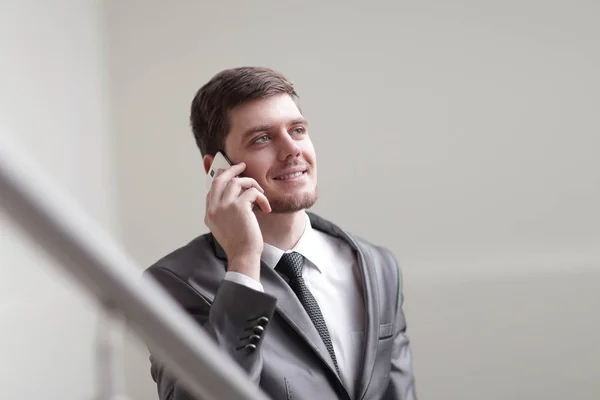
[256,210,306,251]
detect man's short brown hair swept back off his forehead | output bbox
[190,67,298,156]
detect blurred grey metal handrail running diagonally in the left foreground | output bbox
[0,132,267,400]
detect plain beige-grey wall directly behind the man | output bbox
[107,0,600,400]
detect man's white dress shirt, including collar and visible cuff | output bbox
[225,214,364,392]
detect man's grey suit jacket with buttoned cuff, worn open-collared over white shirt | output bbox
[145,213,416,400]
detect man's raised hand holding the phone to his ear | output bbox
[204,162,271,281]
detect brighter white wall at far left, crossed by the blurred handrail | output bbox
[0,0,116,400]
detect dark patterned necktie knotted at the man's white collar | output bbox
[275,252,340,375]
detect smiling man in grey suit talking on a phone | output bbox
[147,67,416,400]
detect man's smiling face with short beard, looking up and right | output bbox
[220,94,317,213]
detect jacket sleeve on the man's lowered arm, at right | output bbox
[382,253,417,400]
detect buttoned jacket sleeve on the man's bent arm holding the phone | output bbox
[145,266,277,400]
